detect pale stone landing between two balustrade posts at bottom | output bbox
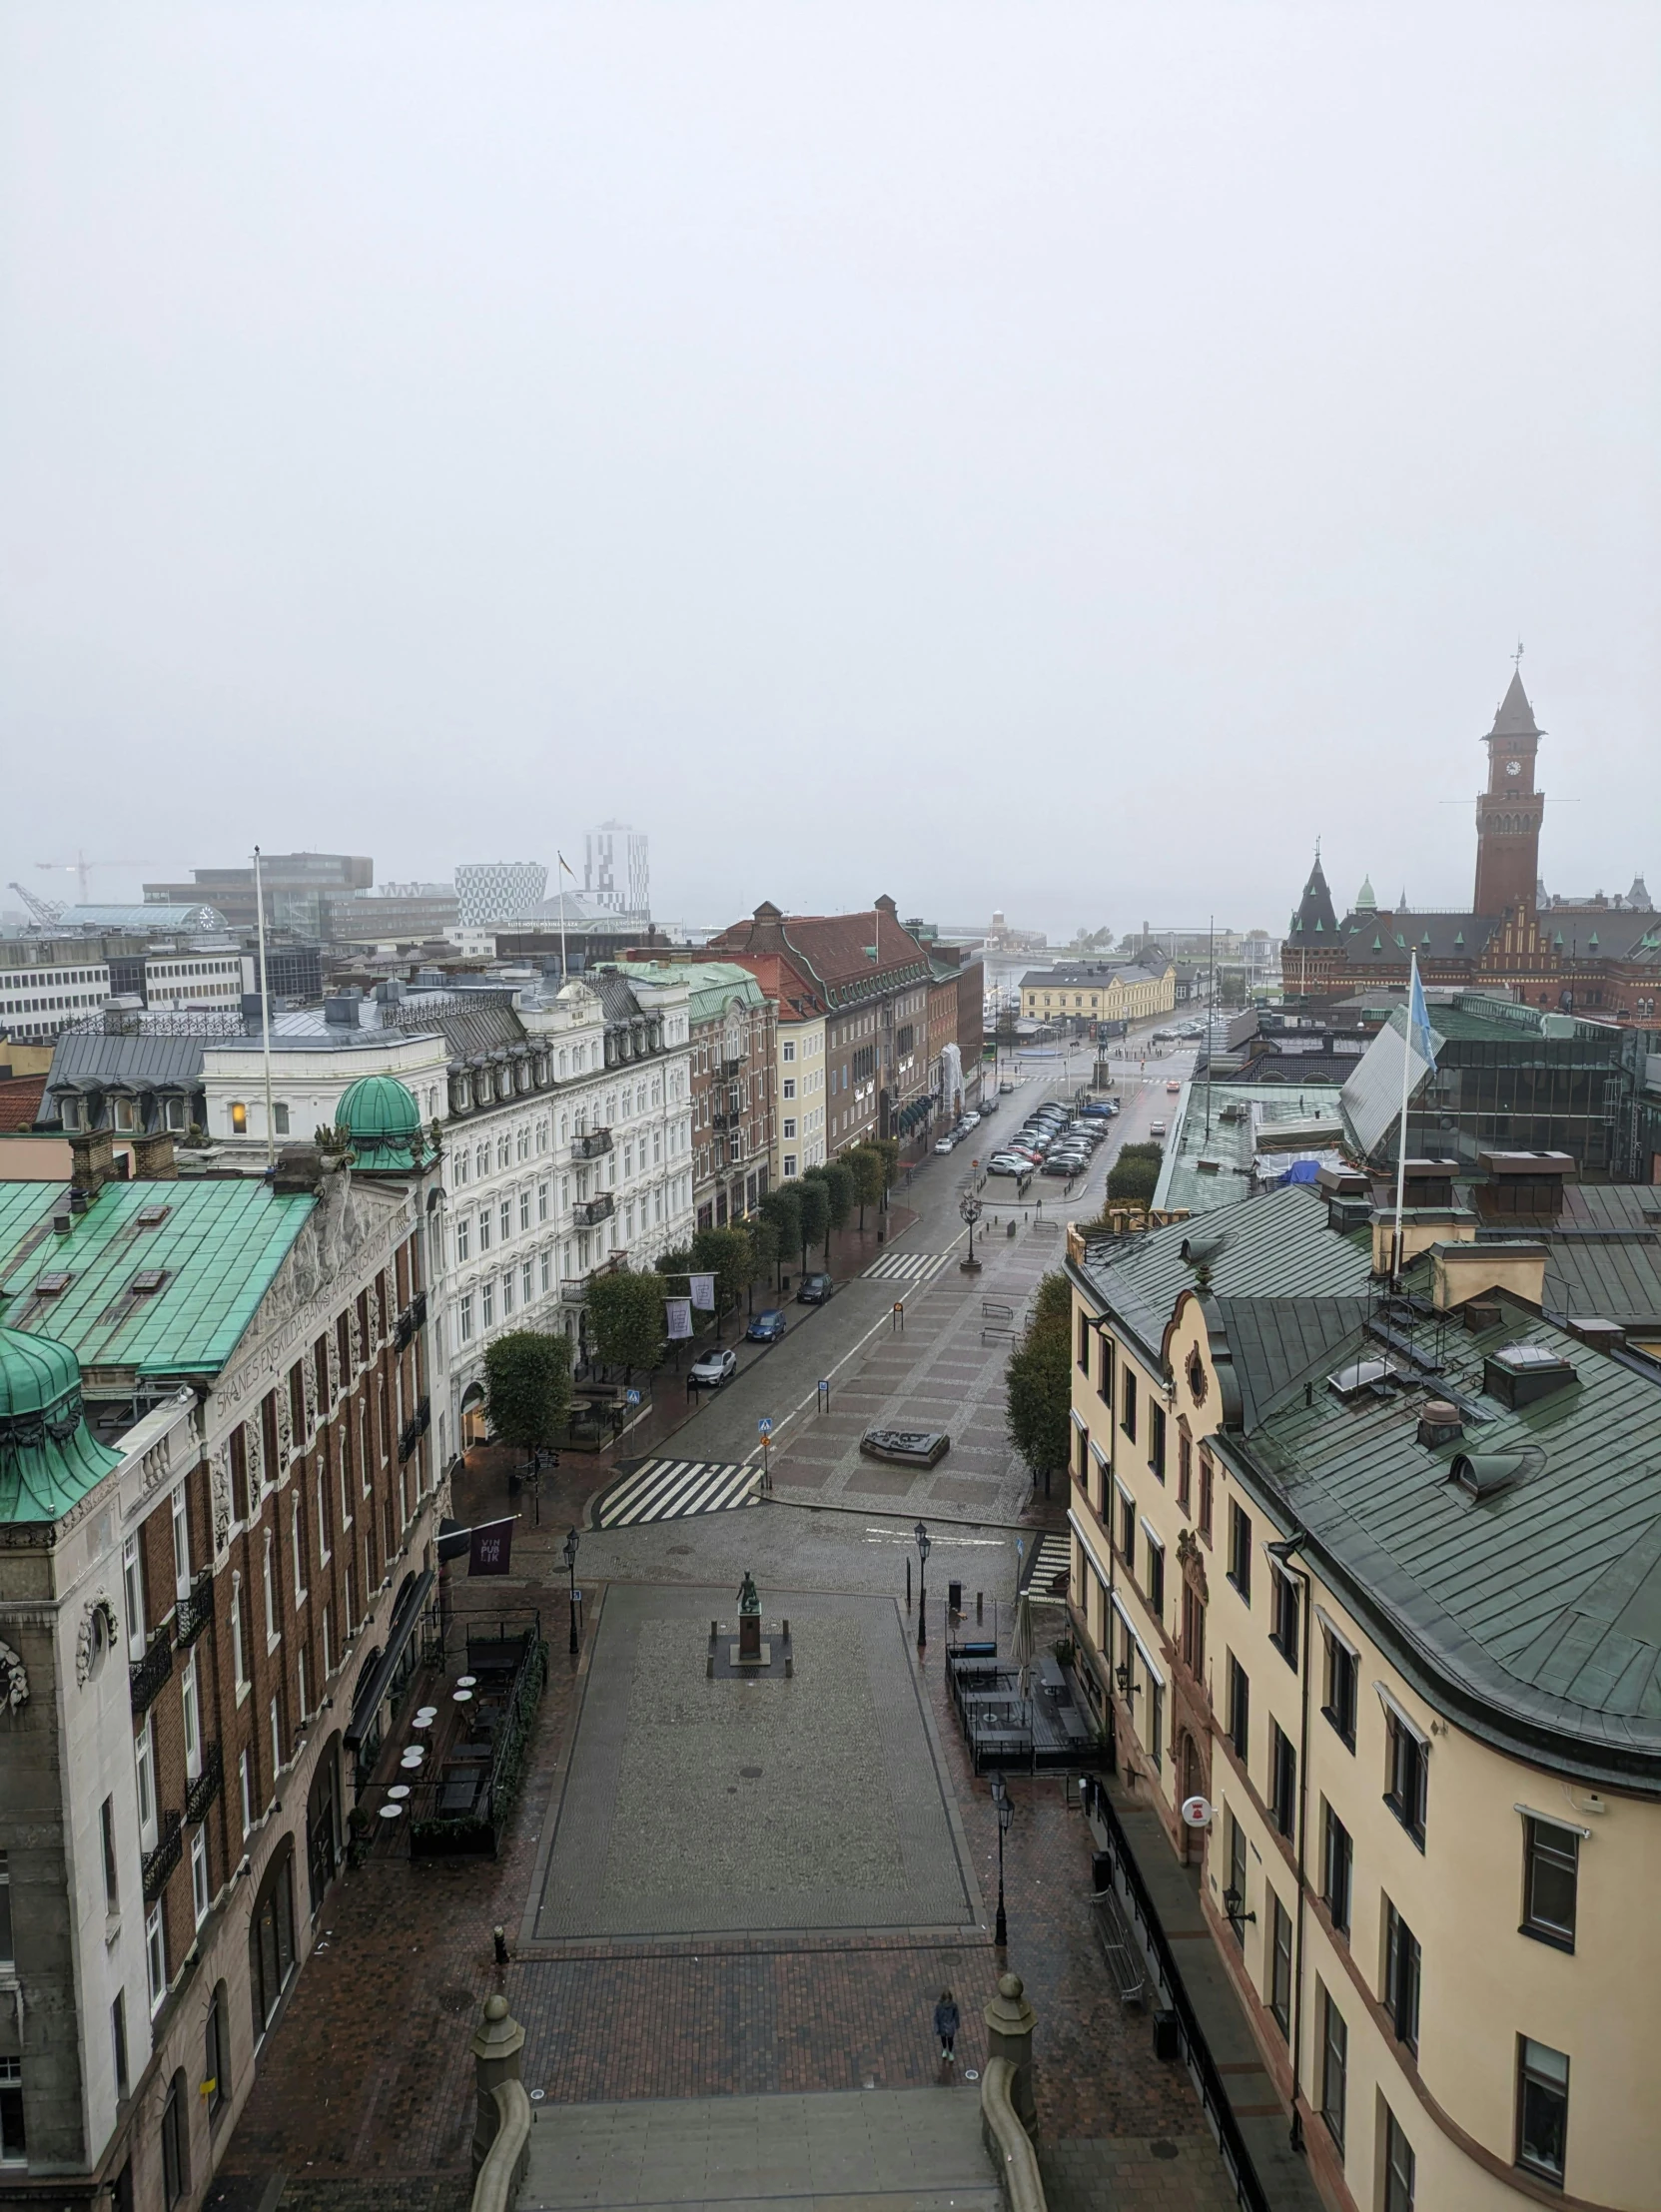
[519,2088,998,2212]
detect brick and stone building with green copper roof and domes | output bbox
[0,1102,442,2212]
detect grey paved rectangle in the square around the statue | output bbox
[535,1584,980,1940]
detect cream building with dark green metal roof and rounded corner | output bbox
[1069,1185,1661,2212]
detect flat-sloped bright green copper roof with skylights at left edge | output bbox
[0,1176,317,1376]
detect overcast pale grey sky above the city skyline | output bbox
[0,0,1661,932]
